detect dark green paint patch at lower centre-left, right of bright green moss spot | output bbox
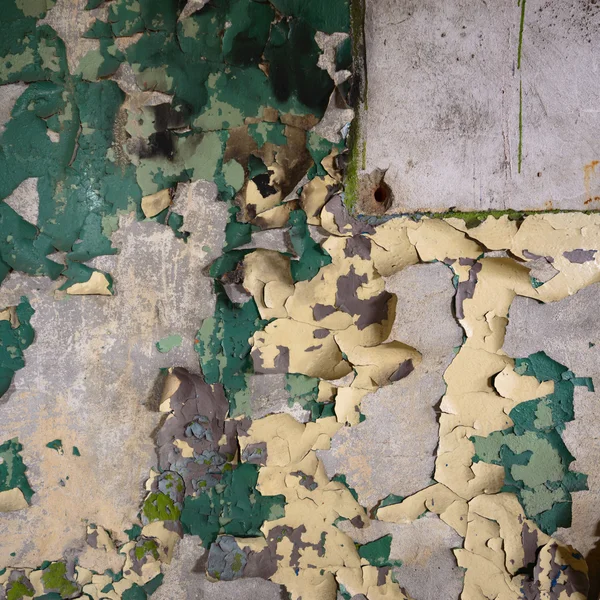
[181,463,285,548]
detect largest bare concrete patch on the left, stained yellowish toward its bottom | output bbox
[0,204,226,566]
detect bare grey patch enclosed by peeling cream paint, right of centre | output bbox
[319,263,462,507]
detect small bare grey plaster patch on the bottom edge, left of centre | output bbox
[152,536,281,600]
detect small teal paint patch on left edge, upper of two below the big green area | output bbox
[0,296,35,397]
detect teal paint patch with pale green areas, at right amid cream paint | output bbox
[471,352,594,535]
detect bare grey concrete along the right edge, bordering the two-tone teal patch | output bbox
[504,285,600,598]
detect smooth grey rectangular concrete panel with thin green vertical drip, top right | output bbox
[363,0,600,212]
